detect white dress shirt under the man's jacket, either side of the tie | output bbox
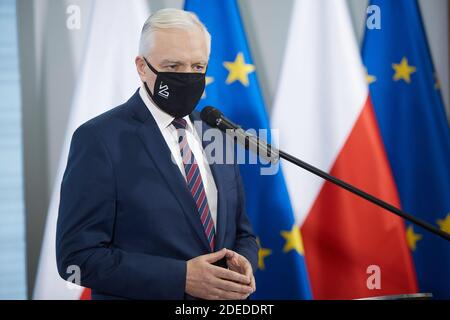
[139,85,217,230]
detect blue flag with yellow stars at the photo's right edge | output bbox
[363,0,450,299]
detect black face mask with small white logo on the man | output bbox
[144,58,205,118]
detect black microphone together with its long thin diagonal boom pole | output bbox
[200,106,450,241]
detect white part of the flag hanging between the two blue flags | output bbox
[272,0,368,225]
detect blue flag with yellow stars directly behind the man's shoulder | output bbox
[185,0,311,299]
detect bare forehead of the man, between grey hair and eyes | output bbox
[150,27,208,61]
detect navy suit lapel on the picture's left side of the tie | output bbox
[130,93,209,250]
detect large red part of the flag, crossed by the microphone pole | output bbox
[301,98,418,299]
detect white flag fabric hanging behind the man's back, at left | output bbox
[33,0,150,300]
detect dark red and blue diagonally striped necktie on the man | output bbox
[172,119,215,251]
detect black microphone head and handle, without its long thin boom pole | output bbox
[200,106,279,163]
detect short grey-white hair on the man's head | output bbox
[139,8,211,56]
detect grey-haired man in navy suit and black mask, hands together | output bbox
[56,9,258,299]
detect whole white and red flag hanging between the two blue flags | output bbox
[272,0,417,299]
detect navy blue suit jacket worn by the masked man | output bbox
[56,92,258,299]
